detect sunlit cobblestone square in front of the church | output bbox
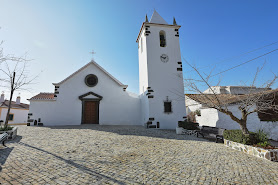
[0,125,278,185]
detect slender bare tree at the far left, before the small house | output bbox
[0,42,37,128]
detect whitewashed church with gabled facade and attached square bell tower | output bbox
[28,11,186,129]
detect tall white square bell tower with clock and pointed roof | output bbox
[136,10,186,129]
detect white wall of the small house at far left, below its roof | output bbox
[0,108,29,124]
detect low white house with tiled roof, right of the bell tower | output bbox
[185,86,278,140]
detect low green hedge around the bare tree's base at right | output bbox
[223,130,268,145]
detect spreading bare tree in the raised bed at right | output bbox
[185,61,278,134]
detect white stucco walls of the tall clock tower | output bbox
[138,24,186,129]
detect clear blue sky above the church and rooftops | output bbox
[0,0,278,102]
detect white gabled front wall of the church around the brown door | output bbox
[30,64,141,126]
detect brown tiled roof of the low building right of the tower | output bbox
[185,89,278,106]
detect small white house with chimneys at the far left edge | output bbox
[0,93,29,125]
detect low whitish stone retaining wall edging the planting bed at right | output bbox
[224,139,278,161]
